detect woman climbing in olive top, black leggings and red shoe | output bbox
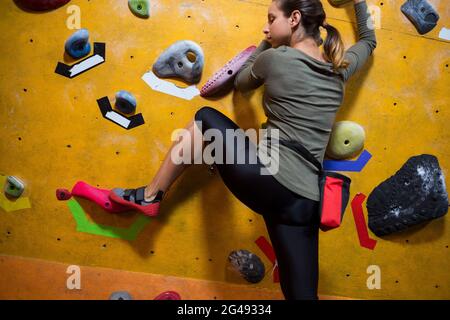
[110,0,376,299]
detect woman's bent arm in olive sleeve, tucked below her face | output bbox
[234,40,272,93]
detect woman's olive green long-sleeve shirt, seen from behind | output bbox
[234,1,376,201]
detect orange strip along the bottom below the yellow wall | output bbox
[0,256,356,300]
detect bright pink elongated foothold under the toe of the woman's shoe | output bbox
[72,181,130,213]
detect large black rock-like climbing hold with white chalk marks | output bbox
[366,154,448,236]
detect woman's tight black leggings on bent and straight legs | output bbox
[195,107,319,299]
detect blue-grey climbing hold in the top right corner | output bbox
[400,0,439,34]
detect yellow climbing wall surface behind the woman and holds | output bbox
[0,0,450,299]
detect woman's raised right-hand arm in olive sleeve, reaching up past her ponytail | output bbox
[340,0,377,81]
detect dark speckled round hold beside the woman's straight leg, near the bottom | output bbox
[228,250,265,283]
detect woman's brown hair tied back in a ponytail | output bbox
[273,0,349,71]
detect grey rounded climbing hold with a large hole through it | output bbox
[153,40,204,83]
